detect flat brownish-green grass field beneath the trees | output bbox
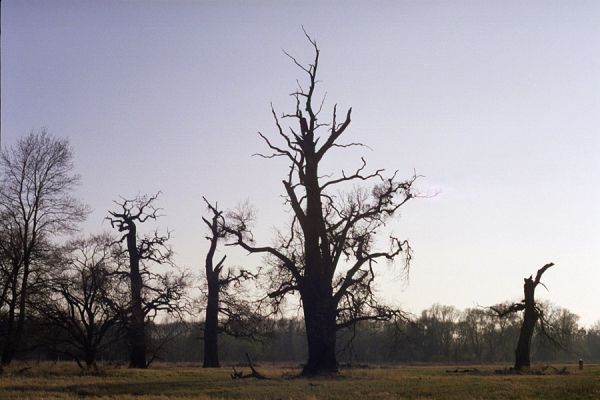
[0,363,600,400]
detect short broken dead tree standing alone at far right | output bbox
[490,263,554,370]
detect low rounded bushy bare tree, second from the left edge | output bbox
[35,234,128,369]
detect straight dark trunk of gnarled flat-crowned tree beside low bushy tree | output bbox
[127,221,147,368]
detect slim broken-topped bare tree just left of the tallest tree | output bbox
[202,198,265,368]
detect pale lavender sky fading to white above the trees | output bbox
[1,0,600,326]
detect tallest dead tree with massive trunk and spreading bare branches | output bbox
[226,35,416,375]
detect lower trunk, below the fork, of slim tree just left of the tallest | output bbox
[202,273,220,368]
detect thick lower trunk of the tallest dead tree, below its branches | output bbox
[302,282,338,376]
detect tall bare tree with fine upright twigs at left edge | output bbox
[0,130,88,365]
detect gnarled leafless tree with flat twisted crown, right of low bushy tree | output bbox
[107,192,188,368]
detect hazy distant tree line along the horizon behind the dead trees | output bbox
[5,304,600,365]
